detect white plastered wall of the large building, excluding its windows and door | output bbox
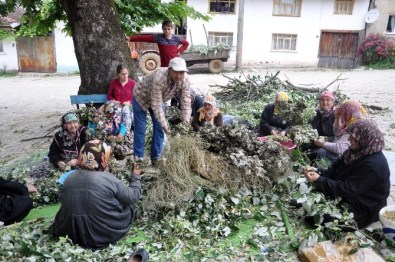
[188,0,369,65]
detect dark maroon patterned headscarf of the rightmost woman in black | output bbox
[343,119,384,165]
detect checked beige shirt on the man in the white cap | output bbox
[133,67,192,133]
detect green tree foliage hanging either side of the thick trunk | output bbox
[0,0,209,36]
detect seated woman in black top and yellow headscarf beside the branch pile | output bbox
[259,92,292,136]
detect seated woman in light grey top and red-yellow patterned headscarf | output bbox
[310,100,366,161]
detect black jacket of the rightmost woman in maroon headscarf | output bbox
[315,152,390,228]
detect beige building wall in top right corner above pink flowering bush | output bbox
[366,0,395,38]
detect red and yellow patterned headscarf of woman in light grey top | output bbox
[335,100,367,136]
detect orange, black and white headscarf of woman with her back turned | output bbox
[78,140,111,171]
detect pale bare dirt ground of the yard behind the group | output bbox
[0,67,395,167]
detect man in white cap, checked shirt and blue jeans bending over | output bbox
[133,57,191,161]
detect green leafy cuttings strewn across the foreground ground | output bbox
[0,167,378,261]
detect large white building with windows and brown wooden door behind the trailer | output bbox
[188,0,369,67]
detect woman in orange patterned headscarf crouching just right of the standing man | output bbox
[192,95,224,131]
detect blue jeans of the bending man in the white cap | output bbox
[133,98,165,160]
